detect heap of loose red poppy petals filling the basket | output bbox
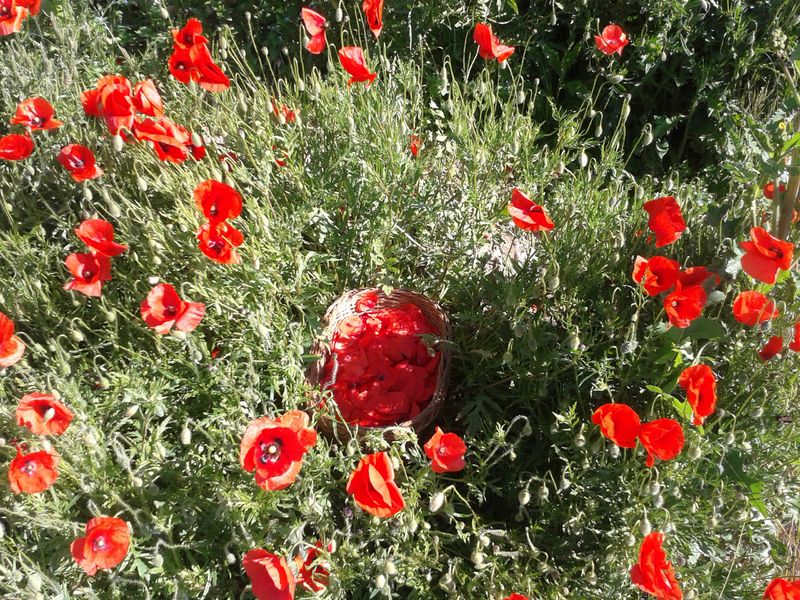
[325,296,439,427]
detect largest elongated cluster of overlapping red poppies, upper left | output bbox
[80,75,206,166]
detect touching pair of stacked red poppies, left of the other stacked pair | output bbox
[64,219,128,297]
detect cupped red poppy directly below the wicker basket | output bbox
[347,452,406,518]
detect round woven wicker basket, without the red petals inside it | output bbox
[306,288,450,440]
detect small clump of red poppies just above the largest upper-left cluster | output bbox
[169,19,231,92]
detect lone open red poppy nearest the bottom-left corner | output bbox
[70,517,131,577]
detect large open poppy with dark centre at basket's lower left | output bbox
[239,410,317,490]
